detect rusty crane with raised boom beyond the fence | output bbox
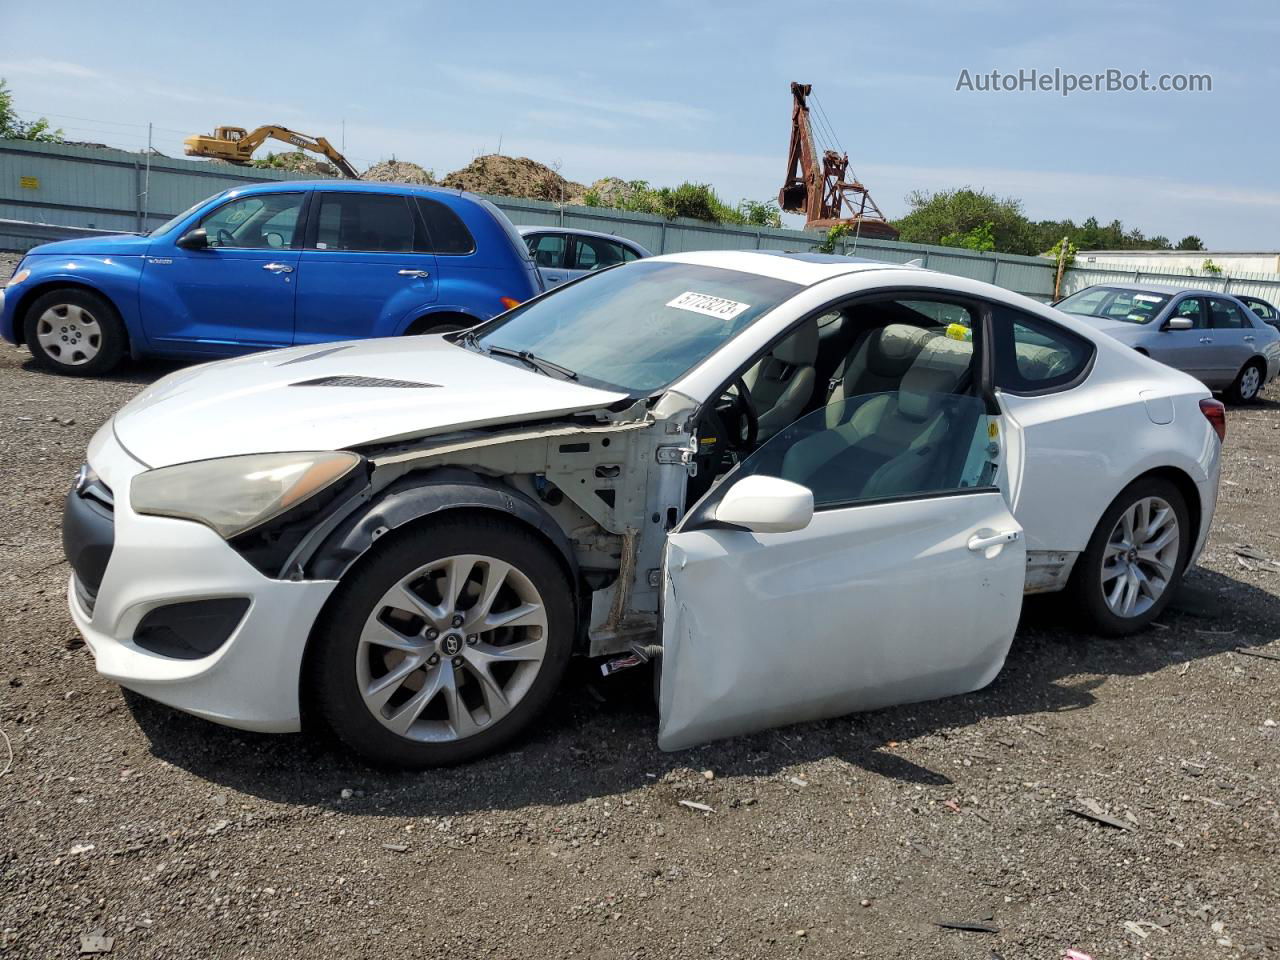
[778,83,897,239]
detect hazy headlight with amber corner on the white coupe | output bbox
[129,452,362,540]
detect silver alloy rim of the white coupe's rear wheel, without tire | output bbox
[1102,497,1180,617]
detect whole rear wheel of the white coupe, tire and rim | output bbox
[1071,477,1194,636]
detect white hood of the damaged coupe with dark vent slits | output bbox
[114,335,626,467]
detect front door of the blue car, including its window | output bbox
[138,191,307,355]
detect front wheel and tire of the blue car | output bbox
[23,287,128,376]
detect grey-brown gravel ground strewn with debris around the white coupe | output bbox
[0,249,1280,960]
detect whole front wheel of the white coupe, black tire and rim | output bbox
[310,516,573,767]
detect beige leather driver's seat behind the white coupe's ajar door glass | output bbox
[782,328,973,503]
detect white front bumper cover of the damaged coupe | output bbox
[67,424,337,732]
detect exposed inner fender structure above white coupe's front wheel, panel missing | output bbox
[302,403,692,657]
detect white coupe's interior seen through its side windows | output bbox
[687,298,1071,506]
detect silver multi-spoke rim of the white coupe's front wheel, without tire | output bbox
[356,554,547,742]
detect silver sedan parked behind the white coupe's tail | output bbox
[1056,284,1280,403]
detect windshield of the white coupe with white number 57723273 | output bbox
[475,260,803,396]
